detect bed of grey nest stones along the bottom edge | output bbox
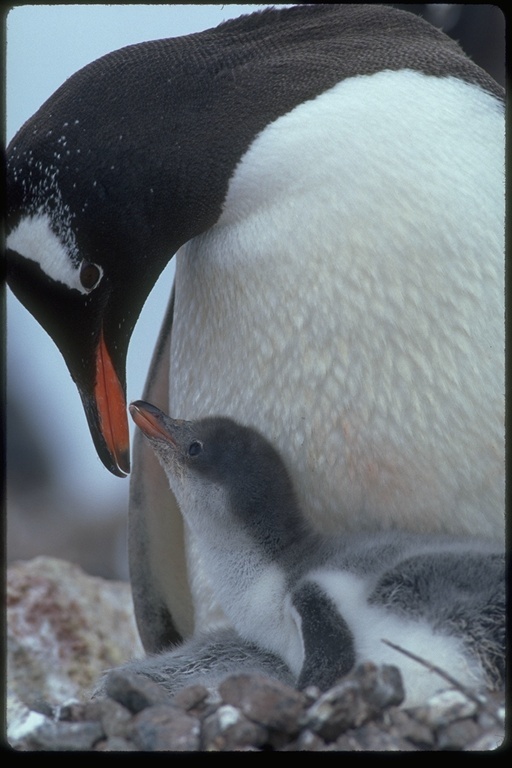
[7,663,505,752]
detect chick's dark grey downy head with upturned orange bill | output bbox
[130,400,307,555]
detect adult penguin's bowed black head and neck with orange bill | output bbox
[6,37,230,476]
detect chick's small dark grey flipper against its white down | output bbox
[292,581,356,690]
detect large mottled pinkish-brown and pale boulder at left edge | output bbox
[7,557,142,716]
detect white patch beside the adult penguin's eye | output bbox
[6,212,99,294]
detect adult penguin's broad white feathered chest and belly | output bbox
[169,72,504,535]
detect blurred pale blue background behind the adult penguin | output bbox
[6,3,505,579]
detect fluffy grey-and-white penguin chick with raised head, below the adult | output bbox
[130,401,505,706]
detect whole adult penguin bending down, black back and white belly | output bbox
[7,4,504,650]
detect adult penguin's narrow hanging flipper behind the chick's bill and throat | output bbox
[128,287,193,653]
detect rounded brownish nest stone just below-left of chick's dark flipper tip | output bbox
[219,674,307,734]
